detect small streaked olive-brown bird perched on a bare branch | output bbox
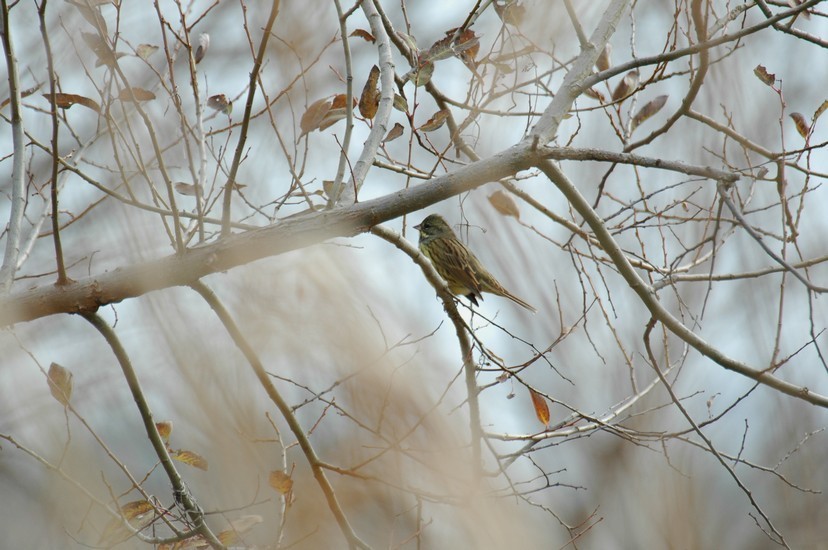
[414,214,537,313]
